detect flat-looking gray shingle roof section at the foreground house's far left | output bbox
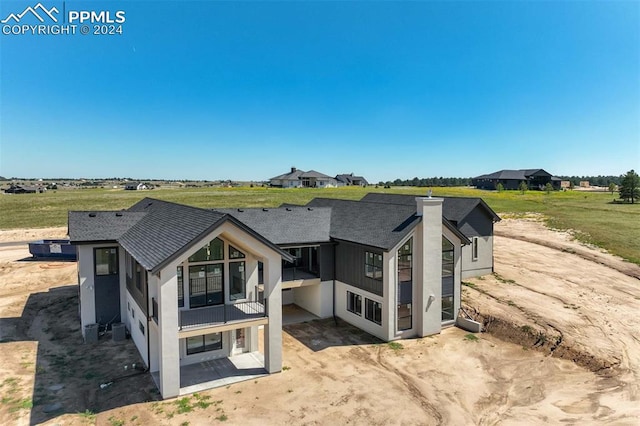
[69,211,145,243]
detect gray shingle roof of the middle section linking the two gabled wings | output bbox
[215,206,331,245]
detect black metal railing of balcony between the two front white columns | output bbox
[179,302,267,330]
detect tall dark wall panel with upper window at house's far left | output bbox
[93,247,120,328]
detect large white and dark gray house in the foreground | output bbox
[69,197,490,398]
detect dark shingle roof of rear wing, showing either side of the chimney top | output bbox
[362,192,500,222]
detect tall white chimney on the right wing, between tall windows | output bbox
[416,197,444,336]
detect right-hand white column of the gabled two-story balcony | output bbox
[264,253,282,373]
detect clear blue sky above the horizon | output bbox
[0,0,640,182]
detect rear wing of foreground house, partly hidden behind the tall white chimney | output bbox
[362,192,500,279]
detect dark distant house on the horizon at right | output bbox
[471,169,561,190]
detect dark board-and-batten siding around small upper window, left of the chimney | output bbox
[336,242,384,297]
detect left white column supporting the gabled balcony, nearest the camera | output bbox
[158,264,180,399]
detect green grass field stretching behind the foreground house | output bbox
[0,187,640,264]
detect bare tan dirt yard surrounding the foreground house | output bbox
[0,220,640,426]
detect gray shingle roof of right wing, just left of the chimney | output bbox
[307,198,421,250]
